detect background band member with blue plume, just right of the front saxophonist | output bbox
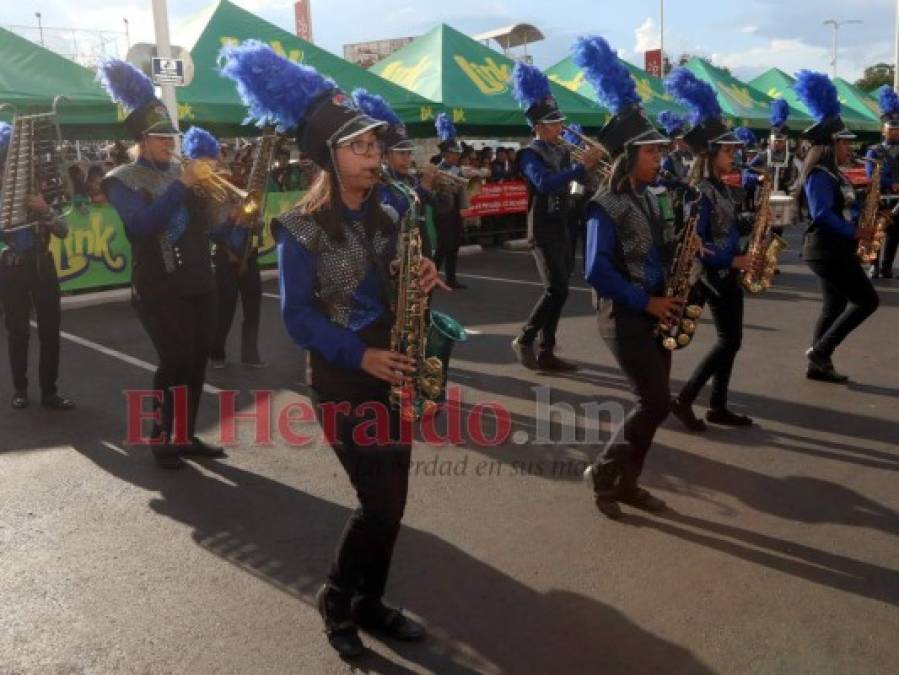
[433,113,468,289]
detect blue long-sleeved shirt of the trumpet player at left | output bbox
[104,158,188,242]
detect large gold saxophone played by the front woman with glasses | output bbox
[381,173,454,421]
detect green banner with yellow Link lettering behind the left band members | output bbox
[39,192,303,292]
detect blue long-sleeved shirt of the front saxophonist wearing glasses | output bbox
[277,209,385,370]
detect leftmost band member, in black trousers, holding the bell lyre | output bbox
[0,122,75,410]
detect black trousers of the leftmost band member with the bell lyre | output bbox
[0,258,61,398]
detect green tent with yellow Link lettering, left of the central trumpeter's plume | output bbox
[371,24,607,135]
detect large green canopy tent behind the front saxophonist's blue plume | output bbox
[173,0,439,136]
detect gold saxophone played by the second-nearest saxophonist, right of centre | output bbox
[656,190,702,351]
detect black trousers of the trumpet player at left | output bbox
[134,292,215,439]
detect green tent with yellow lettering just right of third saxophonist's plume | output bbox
[685,57,812,133]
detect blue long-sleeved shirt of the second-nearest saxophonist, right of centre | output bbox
[584,197,666,312]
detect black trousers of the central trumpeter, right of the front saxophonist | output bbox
[519,236,571,350]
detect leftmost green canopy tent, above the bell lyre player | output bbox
[0,28,121,140]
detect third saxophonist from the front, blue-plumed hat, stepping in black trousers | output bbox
[665,68,752,431]
